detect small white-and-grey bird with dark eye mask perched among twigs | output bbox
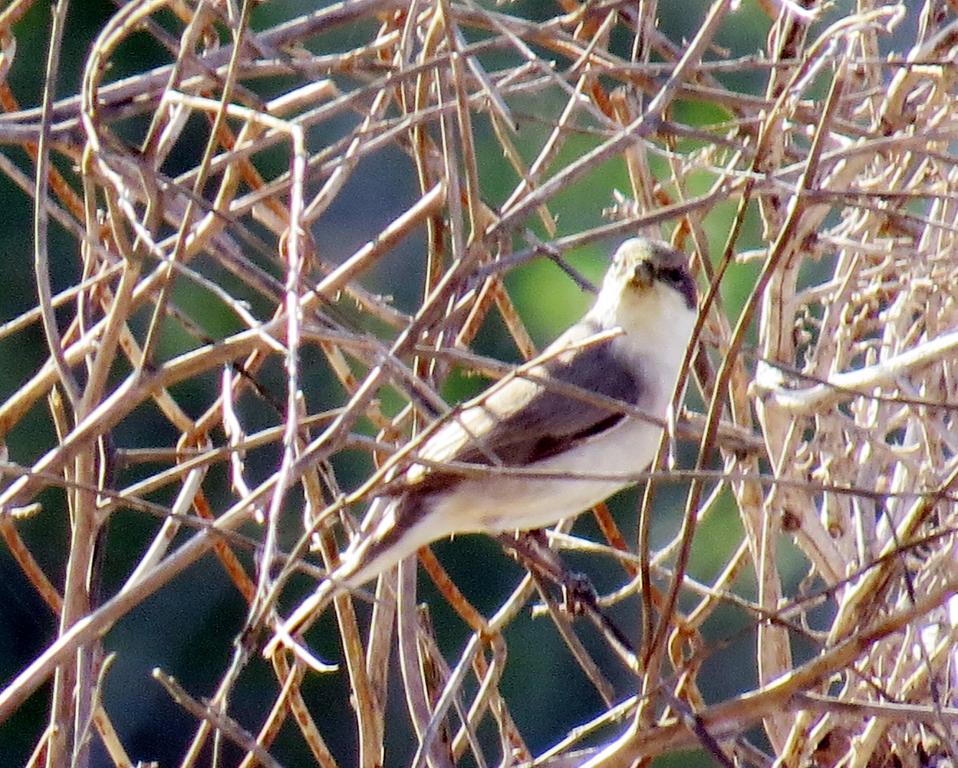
[266,238,696,655]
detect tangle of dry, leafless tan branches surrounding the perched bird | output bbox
[0,0,958,766]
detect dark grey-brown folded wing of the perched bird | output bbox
[404,332,644,493]
